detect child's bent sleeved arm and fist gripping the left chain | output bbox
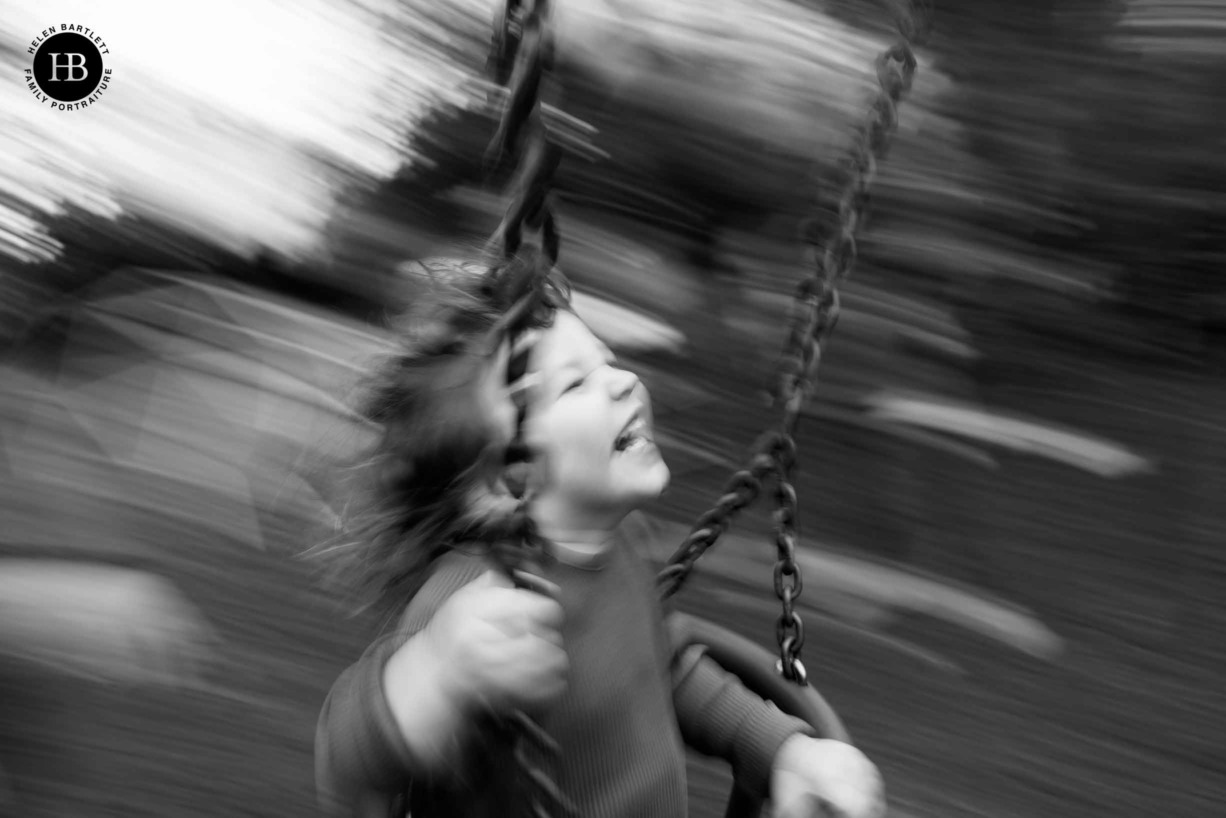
[316,558,565,816]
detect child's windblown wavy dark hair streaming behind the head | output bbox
[311,259,514,613]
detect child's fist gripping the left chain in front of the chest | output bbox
[423,571,568,711]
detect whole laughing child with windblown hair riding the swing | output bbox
[316,261,885,818]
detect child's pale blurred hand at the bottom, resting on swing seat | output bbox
[771,736,885,818]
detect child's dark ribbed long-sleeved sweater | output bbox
[316,527,807,818]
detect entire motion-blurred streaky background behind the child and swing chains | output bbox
[0,0,1226,818]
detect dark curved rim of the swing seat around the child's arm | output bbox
[667,612,851,818]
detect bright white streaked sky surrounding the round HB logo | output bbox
[0,0,441,258]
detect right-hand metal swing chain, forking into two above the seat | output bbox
[658,0,931,684]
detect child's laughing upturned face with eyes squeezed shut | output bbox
[524,312,668,533]
